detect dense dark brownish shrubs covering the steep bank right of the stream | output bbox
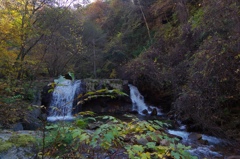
[124,0,240,137]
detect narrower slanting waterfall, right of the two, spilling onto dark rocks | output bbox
[128,84,162,115]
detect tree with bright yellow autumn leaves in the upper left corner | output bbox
[0,0,53,79]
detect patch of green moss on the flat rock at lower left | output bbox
[8,134,36,147]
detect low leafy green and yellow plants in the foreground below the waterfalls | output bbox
[40,112,194,159]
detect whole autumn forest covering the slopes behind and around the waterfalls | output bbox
[0,0,240,158]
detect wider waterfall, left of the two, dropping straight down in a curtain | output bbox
[47,80,81,121]
